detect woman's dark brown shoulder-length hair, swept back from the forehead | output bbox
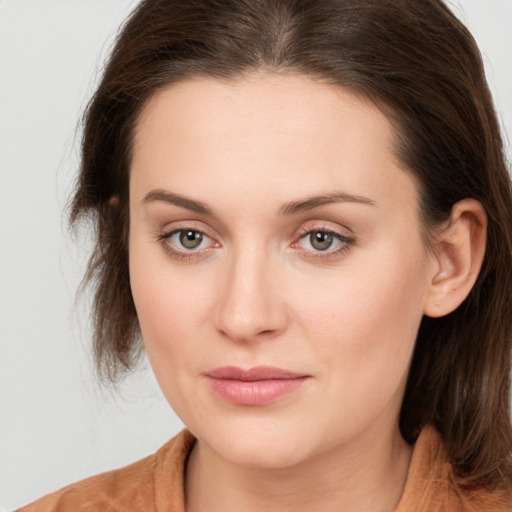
[71,0,512,485]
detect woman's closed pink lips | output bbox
[204,366,311,406]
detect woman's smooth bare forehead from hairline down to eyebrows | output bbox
[131,73,414,214]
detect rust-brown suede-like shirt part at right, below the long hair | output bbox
[396,427,512,512]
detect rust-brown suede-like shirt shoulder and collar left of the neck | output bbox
[18,430,194,512]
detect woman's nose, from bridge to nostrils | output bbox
[215,246,288,342]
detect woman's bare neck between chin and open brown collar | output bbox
[186,427,412,512]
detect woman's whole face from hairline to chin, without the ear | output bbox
[129,73,433,467]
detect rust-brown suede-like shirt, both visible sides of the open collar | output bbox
[18,427,512,512]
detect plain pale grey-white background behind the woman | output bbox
[0,0,512,511]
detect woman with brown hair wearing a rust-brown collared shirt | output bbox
[22,0,512,512]
